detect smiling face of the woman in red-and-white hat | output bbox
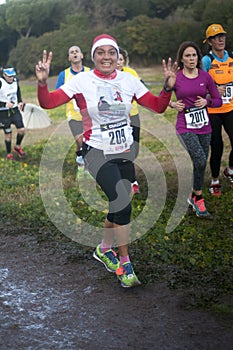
[93,45,118,75]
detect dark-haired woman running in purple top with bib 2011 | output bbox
[170,41,222,218]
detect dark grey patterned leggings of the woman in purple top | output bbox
[179,132,211,191]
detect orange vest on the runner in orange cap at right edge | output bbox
[208,57,233,114]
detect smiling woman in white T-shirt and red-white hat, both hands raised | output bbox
[36,34,177,288]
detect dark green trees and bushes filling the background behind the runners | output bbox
[0,0,233,78]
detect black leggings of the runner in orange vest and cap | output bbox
[209,111,233,178]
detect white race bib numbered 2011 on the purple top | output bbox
[184,107,209,129]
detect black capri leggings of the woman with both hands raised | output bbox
[83,143,134,225]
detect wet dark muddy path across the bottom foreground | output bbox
[0,230,233,350]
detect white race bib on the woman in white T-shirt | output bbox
[100,119,131,154]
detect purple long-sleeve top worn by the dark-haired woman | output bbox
[174,69,222,134]
